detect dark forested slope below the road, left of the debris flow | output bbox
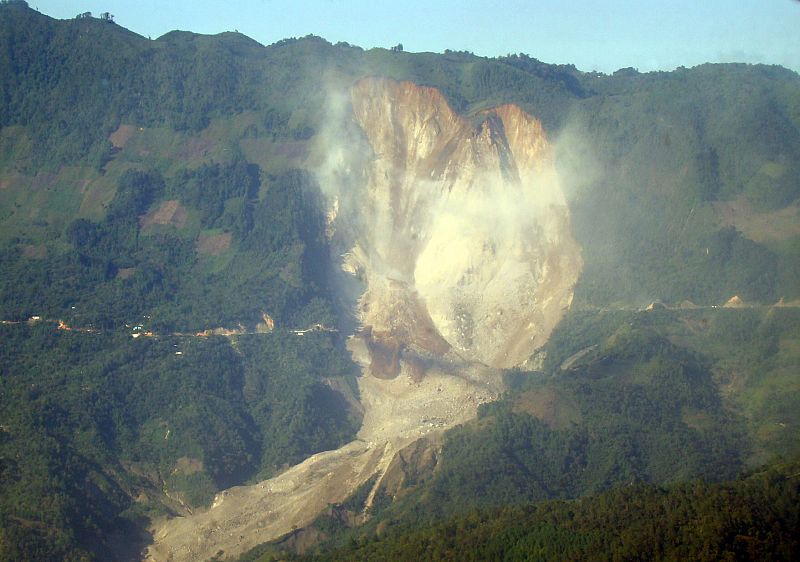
[0,322,358,560]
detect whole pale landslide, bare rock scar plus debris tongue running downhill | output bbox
[147,79,581,562]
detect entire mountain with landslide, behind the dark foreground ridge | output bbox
[0,1,800,560]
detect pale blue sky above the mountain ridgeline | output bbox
[28,0,800,72]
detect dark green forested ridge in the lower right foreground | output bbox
[274,462,800,561]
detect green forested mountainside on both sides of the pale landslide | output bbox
[0,2,800,560]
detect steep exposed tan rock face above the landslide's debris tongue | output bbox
[331,79,582,368]
